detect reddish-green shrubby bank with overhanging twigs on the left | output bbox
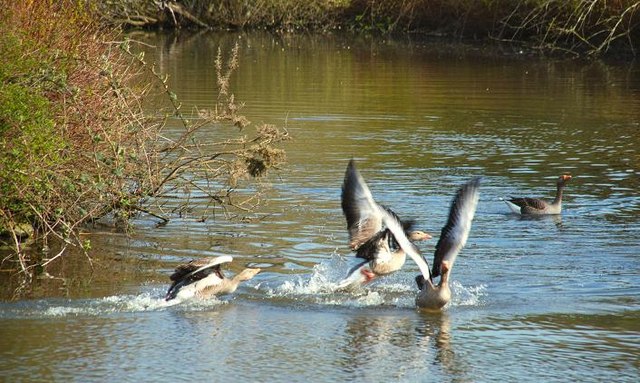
[0,0,287,271]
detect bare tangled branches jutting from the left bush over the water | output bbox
[120,43,289,222]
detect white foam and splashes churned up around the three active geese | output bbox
[28,262,486,317]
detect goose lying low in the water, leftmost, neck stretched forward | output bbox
[165,255,260,301]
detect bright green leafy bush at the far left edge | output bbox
[0,27,65,231]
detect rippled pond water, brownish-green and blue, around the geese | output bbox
[0,34,640,382]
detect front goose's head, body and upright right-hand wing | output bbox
[416,178,480,310]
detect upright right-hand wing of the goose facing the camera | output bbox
[431,178,480,277]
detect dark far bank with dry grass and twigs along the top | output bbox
[101,0,640,57]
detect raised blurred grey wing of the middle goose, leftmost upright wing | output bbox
[342,159,384,250]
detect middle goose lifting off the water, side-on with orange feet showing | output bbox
[338,160,431,288]
